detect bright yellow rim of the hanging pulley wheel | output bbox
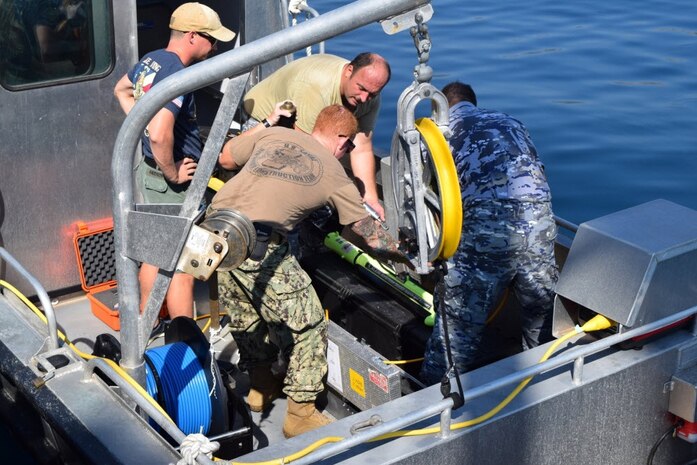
[415,118,462,259]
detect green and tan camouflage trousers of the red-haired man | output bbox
[218,242,327,402]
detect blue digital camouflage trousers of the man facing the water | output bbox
[421,201,559,384]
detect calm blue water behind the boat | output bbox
[324,0,697,223]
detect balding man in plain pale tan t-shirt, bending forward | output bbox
[244,53,390,219]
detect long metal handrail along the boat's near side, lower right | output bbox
[286,306,697,465]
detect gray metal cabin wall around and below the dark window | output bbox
[0,0,136,295]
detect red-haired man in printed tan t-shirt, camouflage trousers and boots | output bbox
[211,105,402,437]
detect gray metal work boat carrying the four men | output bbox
[0,0,697,465]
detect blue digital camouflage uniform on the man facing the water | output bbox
[421,101,558,384]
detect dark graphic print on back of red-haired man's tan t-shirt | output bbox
[247,141,323,186]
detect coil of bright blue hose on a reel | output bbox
[145,342,212,435]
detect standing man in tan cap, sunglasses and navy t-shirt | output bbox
[114,2,235,318]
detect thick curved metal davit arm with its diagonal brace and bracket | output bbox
[111,0,429,384]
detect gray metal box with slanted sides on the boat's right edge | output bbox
[553,200,697,336]
